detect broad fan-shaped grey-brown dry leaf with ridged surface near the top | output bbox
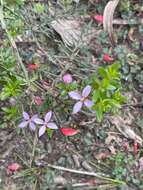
[51,19,101,46]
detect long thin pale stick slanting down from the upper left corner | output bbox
[0,0,29,81]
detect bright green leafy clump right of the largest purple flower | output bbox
[92,63,125,122]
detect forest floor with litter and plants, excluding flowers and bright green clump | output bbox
[0,0,143,190]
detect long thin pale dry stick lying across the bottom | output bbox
[46,164,126,185]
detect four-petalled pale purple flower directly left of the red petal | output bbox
[34,111,58,137]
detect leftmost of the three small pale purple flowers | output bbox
[18,112,38,131]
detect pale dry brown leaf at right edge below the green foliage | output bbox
[111,116,143,144]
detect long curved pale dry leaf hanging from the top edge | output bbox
[103,0,120,45]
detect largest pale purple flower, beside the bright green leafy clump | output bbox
[69,85,93,114]
